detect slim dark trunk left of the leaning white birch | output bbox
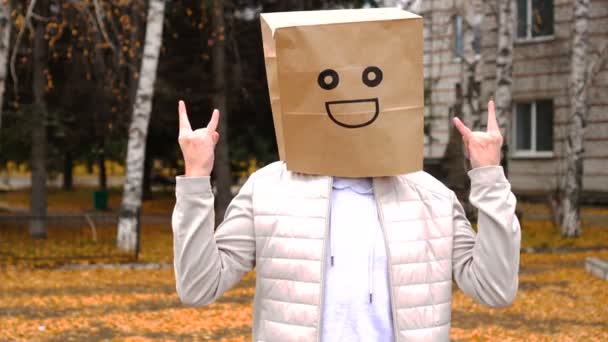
[29,0,49,239]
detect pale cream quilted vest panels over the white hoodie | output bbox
[253,171,454,341]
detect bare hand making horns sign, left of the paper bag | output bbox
[177,101,220,177]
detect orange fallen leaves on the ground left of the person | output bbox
[0,269,255,341]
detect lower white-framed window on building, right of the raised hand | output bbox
[513,100,553,157]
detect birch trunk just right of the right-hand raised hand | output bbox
[495,0,515,175]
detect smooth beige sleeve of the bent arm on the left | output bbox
[171,176,255,306]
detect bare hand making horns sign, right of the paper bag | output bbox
[454,101,503,168]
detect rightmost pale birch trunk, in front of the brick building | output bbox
[561,0,590,237]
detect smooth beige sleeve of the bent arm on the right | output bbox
[452,166,521,307]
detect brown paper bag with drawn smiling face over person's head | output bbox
[261,8,424,177]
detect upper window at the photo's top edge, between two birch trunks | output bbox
[517,0,553,39]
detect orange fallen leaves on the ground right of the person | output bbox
[451,251,608,341]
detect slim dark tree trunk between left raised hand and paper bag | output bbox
[211,0,232,226]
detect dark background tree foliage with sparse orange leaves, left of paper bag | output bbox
[0,0,376,184]
